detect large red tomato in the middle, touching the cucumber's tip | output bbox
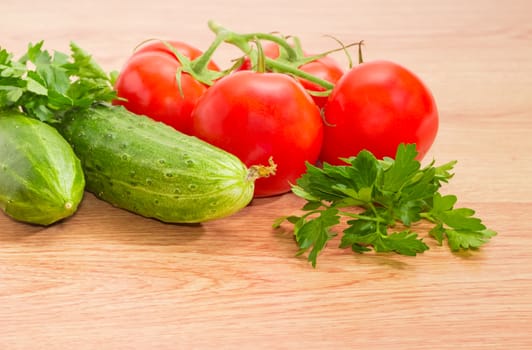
[192,71,323,197]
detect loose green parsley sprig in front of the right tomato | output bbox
[273,144,496,267]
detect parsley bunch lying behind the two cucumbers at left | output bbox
[0,41,116,123]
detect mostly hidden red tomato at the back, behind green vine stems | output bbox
[239,42,344,108]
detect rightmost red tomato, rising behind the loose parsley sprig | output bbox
[321,61,438,164]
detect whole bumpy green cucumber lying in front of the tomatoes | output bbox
[57,105,254,223]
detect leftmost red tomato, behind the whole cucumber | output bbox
[115,41,218,134]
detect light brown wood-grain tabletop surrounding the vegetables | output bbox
[0,0,532,349]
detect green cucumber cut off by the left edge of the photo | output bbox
[0,111,85,226]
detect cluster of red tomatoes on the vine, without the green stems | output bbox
[116,37,438,197]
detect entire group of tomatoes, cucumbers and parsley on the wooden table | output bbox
[0,22,496,266]
